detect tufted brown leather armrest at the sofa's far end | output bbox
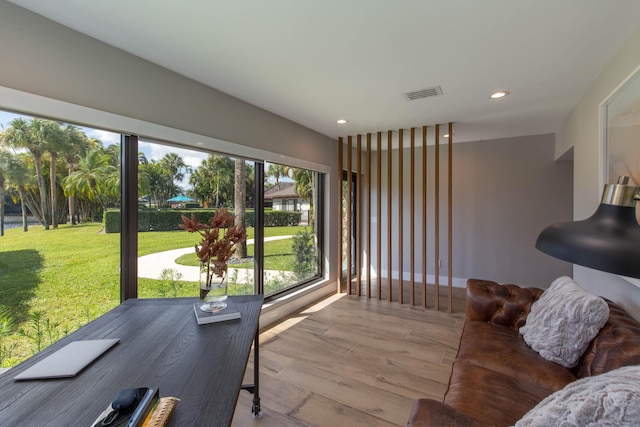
[466,279,543,329]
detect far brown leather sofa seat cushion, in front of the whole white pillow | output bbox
[457,321,576,392]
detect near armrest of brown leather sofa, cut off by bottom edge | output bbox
[407,399,488,427]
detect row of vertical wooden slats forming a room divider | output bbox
[338,123,453,312]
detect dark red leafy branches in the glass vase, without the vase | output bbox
[179,208,247,285]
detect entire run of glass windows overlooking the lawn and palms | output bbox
[0,112,324,367]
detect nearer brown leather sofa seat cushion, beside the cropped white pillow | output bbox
[444,361,553,426]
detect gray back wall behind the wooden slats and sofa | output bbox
[363,134,573,288]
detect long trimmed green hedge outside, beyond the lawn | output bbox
[103,209,302,233]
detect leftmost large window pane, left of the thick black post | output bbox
[0,112,120,367]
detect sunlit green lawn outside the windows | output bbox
[0,223,304,367]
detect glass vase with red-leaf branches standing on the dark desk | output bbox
[179,208,247,312]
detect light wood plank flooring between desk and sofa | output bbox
[232,287,465,427]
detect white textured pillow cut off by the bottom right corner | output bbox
[515,366,640,427]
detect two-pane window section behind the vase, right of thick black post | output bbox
[138,145,320,297]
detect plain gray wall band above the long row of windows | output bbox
[0,0,336,165]
